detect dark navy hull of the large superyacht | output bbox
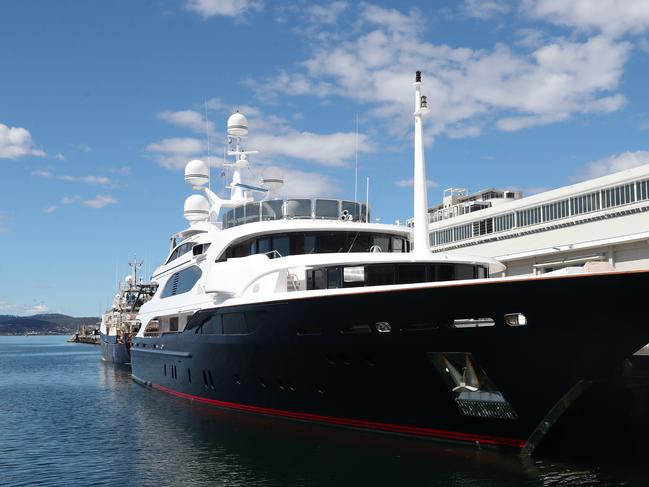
[132,272,649,452]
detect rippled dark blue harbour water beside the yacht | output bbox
[0,336,649,487]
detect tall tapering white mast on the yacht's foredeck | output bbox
[413,71,430,254]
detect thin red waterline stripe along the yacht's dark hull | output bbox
[151,384,525,448]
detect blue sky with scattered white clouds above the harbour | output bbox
[0,0,649,316]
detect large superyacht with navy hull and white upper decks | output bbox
[131,72,649,452]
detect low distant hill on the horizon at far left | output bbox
[0,313,100,335]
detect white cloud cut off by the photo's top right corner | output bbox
[523,0,649,36]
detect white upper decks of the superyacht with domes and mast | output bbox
[138,72,503,337]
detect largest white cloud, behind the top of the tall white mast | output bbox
[256,5,631,136]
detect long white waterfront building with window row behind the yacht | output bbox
[422,165,649,276]
